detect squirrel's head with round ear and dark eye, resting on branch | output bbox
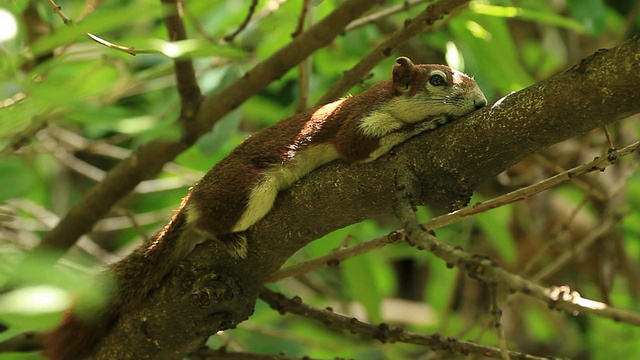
[392,57,487,123]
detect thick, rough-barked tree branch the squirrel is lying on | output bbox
[98,36,640,359]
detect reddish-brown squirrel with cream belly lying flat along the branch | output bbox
[45,57,487,360]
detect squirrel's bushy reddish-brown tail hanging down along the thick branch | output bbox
[44,195,204,360]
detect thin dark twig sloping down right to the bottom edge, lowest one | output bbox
[260,287,553,360]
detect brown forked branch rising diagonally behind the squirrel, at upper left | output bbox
[40,0,374,253]
